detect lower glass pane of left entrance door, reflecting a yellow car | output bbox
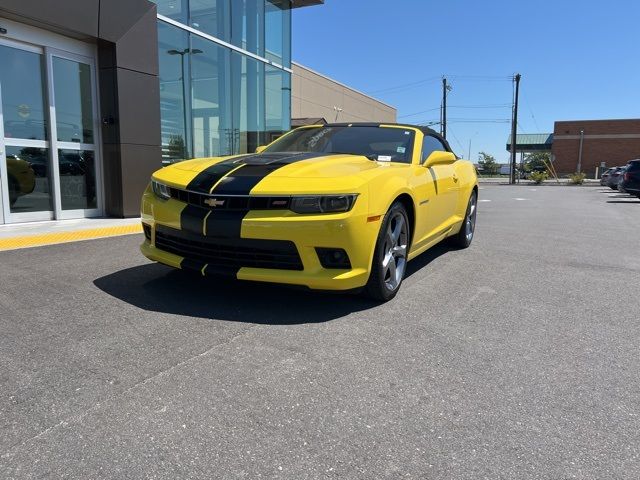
[6,147,53,213]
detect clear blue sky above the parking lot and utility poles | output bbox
[293,0,640,162]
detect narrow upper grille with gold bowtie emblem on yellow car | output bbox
[170,188,291,210]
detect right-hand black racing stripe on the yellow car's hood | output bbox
[212,152,332,195]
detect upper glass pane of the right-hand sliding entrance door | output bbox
[53,57,93,143]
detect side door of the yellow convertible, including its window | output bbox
[414,135,459,248]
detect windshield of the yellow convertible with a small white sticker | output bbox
[264,125,415,163]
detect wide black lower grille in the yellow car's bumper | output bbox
[155,225,304,270]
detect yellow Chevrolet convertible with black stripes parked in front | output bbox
[141,123,478,301]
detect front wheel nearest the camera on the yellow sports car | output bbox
[364,201,411,302]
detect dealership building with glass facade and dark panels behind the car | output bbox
[0,0,344,224]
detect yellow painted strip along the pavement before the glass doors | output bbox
[0,223,142,251]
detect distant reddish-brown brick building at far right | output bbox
[552,119,640,177]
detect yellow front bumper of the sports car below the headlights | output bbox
[141,190,381,290]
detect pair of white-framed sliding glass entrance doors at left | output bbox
[0,40,101,223]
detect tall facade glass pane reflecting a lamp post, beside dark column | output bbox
[158,22,190,163]
